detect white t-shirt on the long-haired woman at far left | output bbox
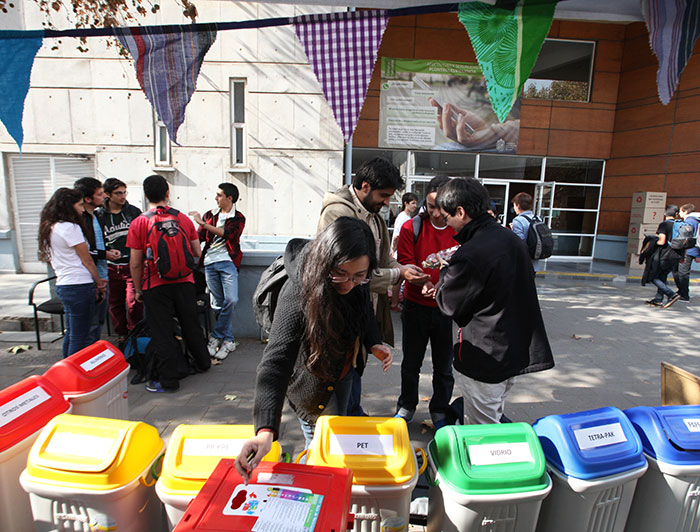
[51,222,93,285]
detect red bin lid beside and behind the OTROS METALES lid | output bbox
[44,340,129,395]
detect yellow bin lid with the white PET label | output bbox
[306,416,416,485]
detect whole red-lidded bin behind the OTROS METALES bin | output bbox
[44,340,129,419]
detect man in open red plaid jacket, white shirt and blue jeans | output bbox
[190,183,245,360]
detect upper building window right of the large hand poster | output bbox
[523,39,595,102]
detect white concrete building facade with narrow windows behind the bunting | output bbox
[0,0,344,272]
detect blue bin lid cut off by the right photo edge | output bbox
[625,405,700,465]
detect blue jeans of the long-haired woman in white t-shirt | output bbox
[56,283,95,358]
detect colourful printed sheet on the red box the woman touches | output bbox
[222,484,323,532]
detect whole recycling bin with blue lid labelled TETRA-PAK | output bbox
[533,407,647,532]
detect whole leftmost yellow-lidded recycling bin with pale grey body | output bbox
[20,414,164,532]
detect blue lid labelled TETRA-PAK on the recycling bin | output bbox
[533,406,646,480]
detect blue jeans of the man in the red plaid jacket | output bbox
[204,260,238,342]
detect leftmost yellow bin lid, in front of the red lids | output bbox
[27,414,164,491]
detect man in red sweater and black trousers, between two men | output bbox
[396,176,457,428]
